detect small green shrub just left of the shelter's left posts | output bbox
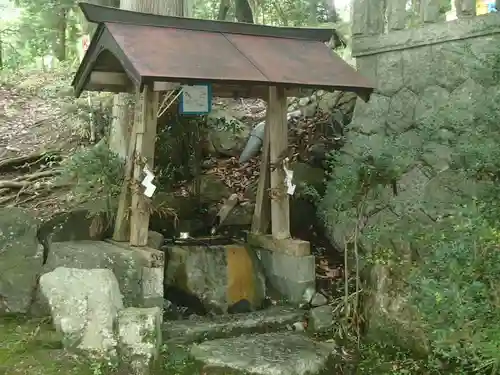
[61,142,124,214]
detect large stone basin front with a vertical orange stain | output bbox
[165,245,266,312]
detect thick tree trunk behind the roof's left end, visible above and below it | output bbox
[109,0,187,159]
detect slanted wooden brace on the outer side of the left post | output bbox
[113,92,142,242]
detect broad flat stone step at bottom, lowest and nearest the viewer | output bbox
[190,332,336,375]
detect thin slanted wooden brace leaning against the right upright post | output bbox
[251,106,271,234]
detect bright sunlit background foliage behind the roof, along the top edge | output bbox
[0,0,348,70]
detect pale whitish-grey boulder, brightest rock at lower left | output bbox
[40,267,123,357]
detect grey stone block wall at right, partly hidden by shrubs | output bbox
[328,1,500,346]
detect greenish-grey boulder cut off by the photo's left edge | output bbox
[0,208,42,314]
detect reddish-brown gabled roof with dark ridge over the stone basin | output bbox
[72,3,373,98]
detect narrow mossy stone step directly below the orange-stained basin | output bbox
[163,306,305,344]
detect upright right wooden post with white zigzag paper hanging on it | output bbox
[267,86,290,240]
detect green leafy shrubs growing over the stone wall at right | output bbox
[321,41,500,374]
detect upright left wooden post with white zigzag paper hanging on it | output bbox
[130,86,159,246]
